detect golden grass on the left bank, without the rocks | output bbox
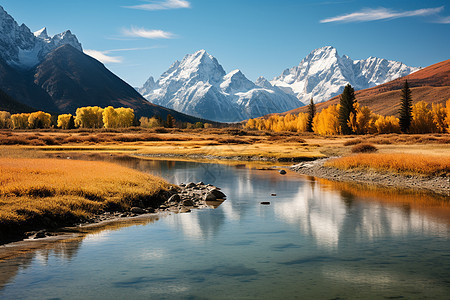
[0,158,169,239]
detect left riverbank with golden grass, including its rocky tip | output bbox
[0,157,224,244]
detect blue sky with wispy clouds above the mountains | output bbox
[0,0,450,86]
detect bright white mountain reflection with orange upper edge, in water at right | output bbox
[275,182,450,249]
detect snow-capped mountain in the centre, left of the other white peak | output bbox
[138,50,302,122]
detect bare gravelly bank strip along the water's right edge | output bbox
[290,157,450,196]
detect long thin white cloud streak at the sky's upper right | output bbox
[320,6,444,23]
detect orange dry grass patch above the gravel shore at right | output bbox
[325,153,450,177]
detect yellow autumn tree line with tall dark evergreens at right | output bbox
[244,81,450,135]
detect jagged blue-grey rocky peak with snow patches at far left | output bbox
[0,6,82,69]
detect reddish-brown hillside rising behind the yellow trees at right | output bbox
[274,59,450,115]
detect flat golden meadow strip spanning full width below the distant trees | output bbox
[0,128,450,161]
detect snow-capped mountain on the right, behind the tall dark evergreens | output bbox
[271,46,420,103]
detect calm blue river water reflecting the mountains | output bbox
[0,159,450,299]
